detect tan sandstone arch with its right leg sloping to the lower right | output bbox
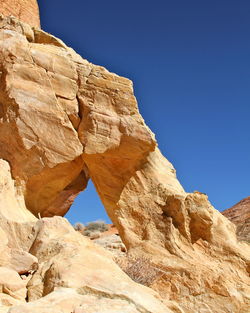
[0,17,249,312]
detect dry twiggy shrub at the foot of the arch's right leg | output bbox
[115,256,164,286]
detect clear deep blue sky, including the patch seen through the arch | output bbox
[39,0,250,223]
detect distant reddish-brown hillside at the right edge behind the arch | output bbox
[222,197,250,243]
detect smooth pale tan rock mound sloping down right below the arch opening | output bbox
[25,217,171,313]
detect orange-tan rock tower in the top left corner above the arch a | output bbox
[0,0,40,27]
